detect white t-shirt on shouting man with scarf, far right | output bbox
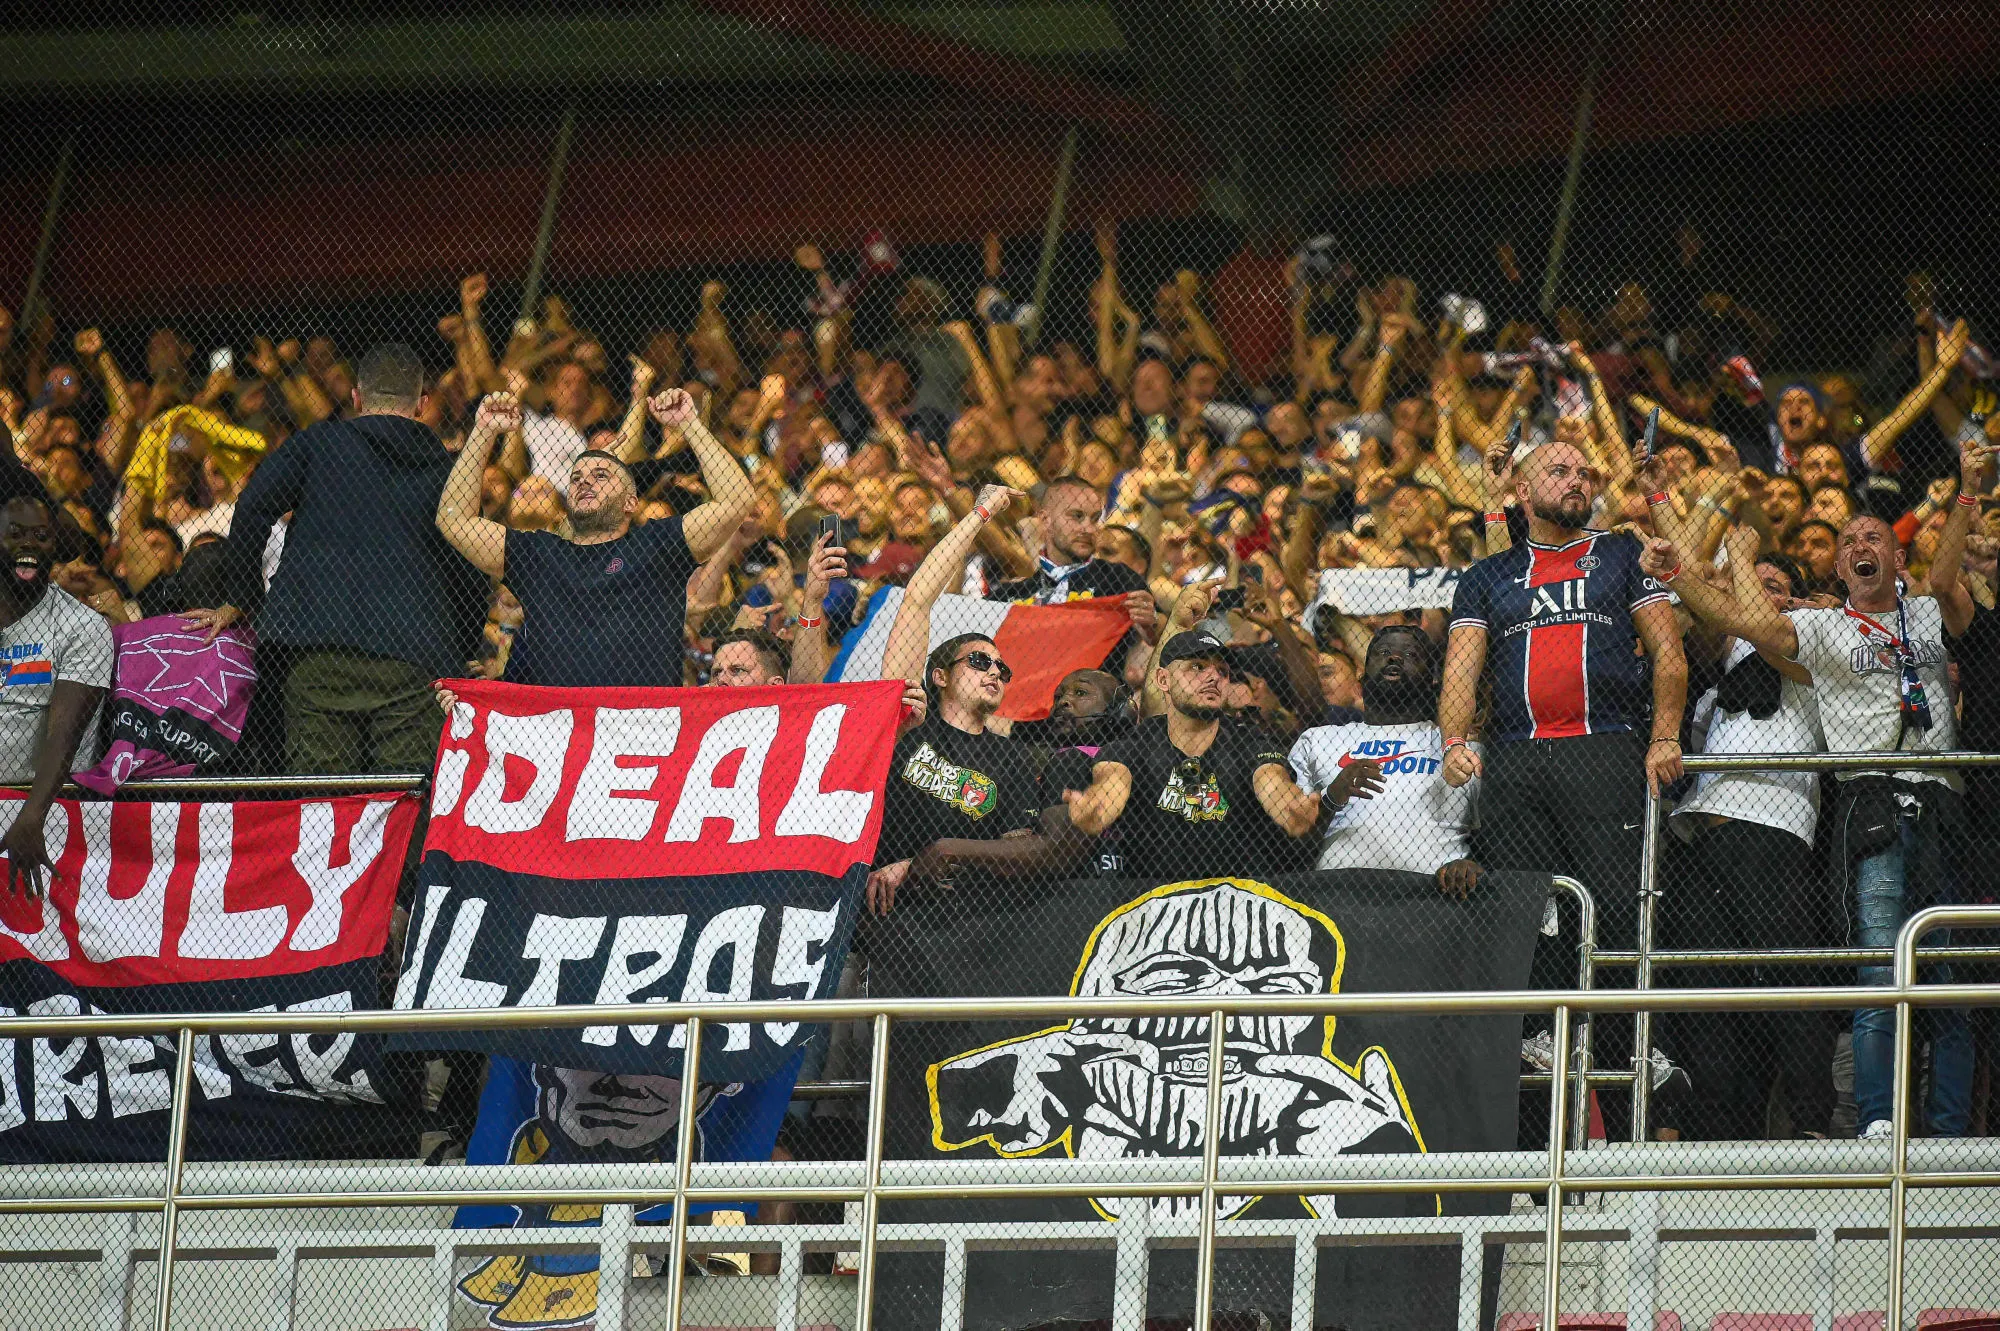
[1786,596,1964,789]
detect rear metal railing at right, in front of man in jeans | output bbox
[1632,749,2000,1141]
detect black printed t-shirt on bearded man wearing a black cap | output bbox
[1098,715,1298,879]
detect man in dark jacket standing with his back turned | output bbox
[188,342,490,773]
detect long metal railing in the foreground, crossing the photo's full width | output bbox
[0,905,2000,1331]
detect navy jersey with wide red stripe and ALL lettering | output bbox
[1452,532,1668,743]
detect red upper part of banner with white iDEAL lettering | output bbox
[424,679,902,879]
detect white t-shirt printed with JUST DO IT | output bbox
[1292,721,1478,873]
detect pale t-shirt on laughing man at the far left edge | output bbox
[0,586,112,783]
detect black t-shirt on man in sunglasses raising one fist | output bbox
[876,715,1040,863]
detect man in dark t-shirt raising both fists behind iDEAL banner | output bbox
[436,388,752,687]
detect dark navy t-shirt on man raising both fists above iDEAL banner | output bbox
[502,518,696,687]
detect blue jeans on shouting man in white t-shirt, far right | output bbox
[1854,809,1972,1137]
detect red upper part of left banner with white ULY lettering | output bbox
[0,795,418,989]
